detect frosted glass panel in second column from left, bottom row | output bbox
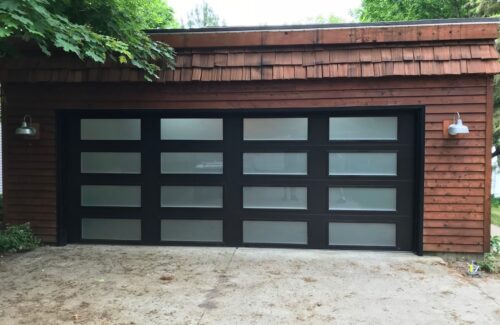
[161,219,222,242]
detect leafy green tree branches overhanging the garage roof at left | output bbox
[0,0,175,80]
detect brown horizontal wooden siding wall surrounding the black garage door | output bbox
[2,76,493,252]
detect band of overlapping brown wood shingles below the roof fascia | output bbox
[0,44,500,82]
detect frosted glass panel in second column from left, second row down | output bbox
[161,152,222,174]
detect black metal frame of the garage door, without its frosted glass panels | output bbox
[57,107,424,254]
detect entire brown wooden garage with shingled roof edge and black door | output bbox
[0,19,500,254]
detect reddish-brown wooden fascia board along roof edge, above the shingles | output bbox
[150,18,500,48]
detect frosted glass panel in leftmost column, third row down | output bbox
[81,185,141,207]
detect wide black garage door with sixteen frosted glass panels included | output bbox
[60,108,420,250]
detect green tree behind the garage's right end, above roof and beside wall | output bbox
[356,0,500,157]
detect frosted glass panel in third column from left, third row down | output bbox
[243,186,307,209]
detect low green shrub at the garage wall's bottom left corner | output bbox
[0,223,40,252]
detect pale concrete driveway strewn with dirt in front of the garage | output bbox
[0,245,500,325]
